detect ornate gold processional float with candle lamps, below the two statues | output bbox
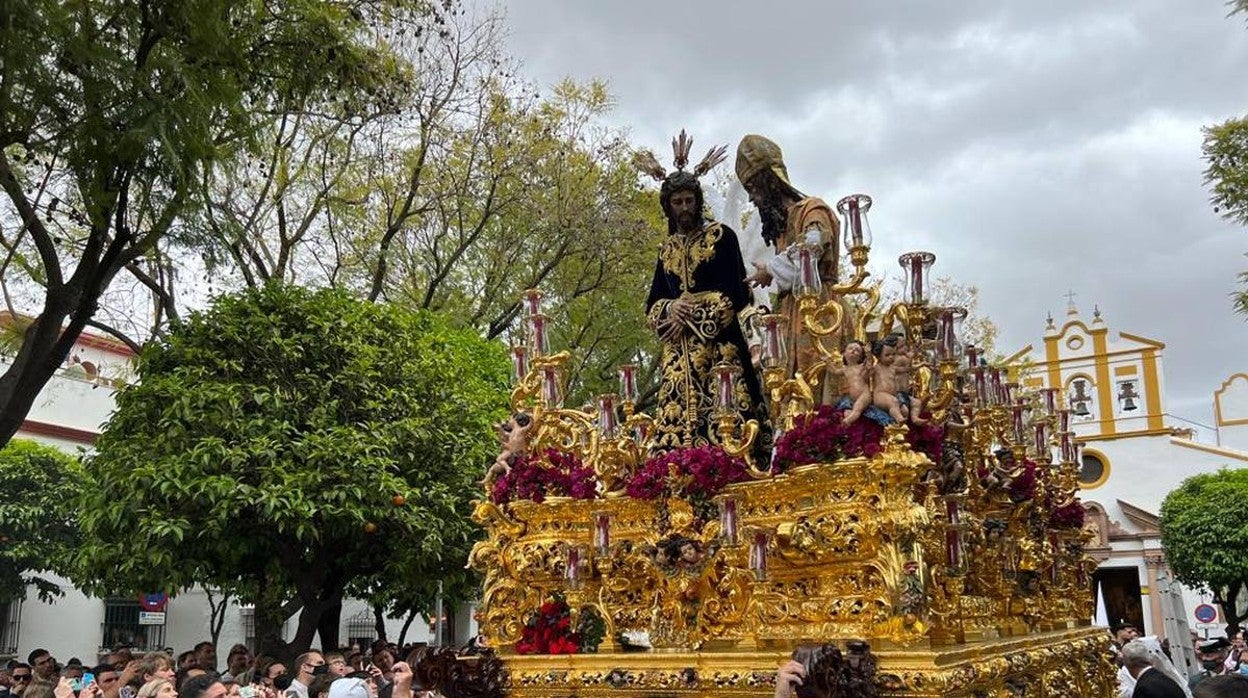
[424,183,1116,698]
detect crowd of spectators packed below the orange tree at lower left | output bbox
[0,641,434,698]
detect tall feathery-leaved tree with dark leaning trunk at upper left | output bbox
[0,0,446,445]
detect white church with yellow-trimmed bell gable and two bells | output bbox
[1007,307,1248,646]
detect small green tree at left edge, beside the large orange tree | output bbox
[0,438,81,601]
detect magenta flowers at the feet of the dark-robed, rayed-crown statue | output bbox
[626,446,750,499]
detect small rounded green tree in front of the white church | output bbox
[1161,468,1248,633]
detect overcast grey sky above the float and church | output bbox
[503,0,1248,422]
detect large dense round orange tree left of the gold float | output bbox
[76,285,507,656]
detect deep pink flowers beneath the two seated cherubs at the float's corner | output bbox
[773,405,945,472]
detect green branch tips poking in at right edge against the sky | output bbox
[1201,0,1248,315]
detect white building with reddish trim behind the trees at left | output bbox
[0,313,449,669]
